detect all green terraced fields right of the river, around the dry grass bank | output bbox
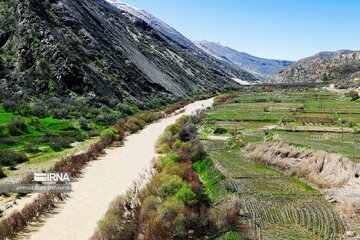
[199,92,354,240]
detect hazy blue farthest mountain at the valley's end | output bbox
[194,40,293,79]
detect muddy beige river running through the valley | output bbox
[22,99,213,240]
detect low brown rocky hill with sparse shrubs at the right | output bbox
[266,50,360,83]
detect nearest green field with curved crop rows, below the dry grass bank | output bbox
[205,141,343,239]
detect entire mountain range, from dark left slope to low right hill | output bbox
[0,0,360,108]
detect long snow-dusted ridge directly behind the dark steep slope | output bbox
[106,0,257,82]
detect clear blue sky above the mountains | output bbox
[124,0,360,60]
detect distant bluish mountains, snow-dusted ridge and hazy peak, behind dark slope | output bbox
[107,0,293,82]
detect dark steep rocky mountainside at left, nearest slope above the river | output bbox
[0,0,254,107]
